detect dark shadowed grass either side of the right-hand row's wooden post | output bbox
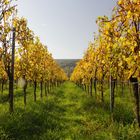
[81,98,135,125]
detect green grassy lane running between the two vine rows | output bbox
[0,82,140,140]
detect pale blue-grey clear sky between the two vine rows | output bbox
[17,0,116,59]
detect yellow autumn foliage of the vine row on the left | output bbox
[0,0,67,82]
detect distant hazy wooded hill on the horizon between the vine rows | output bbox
[55,59,80,77]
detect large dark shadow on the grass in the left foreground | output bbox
[0,98,70,140]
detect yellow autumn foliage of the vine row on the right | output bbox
[71,0,140,85]
